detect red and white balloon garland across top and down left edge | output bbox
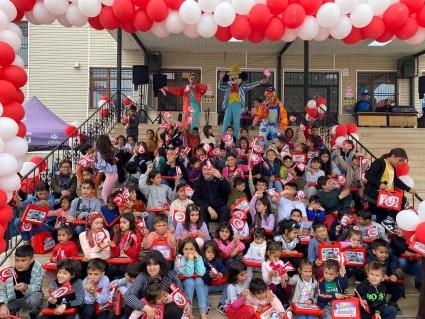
[0,0,425,252]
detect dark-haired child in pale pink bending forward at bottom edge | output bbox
[245,278,289,319]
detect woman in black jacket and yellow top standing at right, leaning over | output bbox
[363,148,416,234]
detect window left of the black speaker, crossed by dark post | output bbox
[90,68,133,108]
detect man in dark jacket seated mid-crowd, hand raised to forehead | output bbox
[192,161,230,224]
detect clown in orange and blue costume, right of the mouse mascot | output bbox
[257,87,288,145]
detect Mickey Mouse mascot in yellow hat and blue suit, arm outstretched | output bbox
[217,65,267,138]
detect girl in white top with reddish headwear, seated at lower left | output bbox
[79,213,111,262]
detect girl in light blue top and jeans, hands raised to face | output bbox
[174,237,208,319]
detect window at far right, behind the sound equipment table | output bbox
[357,72,398,110]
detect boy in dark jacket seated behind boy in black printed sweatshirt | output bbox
[366,238,406,312]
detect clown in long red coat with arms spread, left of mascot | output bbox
[161,73,208,132]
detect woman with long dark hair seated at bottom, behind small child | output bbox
[124,250,190,319]
